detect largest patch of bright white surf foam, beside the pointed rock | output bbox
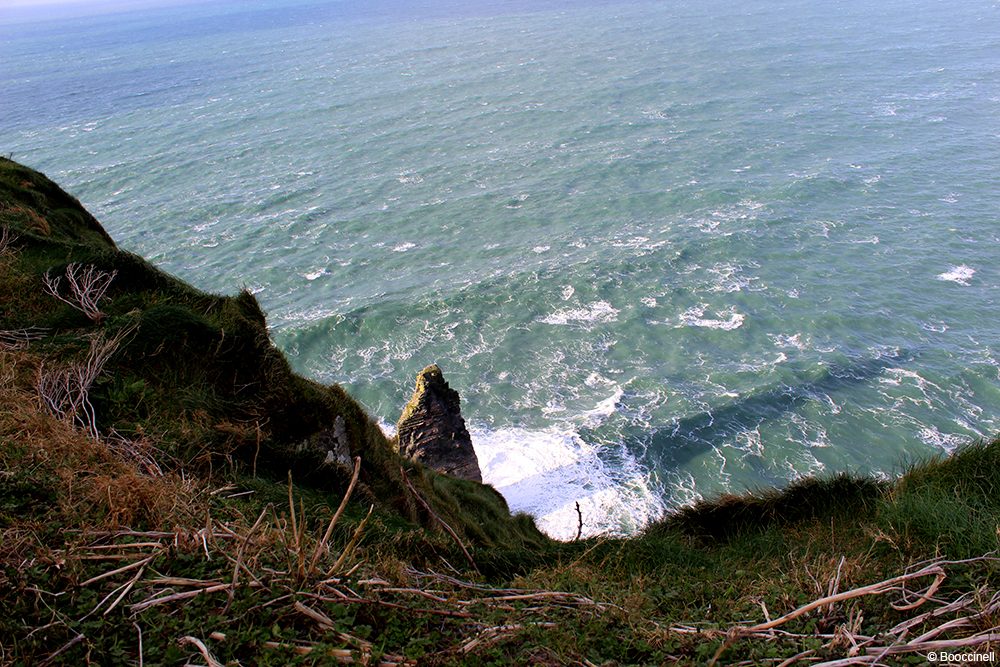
[470,425,664,540]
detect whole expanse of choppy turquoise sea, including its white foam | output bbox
[0,0,1000,536]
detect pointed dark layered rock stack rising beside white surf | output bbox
[397,365,483,482]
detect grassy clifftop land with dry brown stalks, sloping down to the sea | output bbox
[0,159,1000,665]
